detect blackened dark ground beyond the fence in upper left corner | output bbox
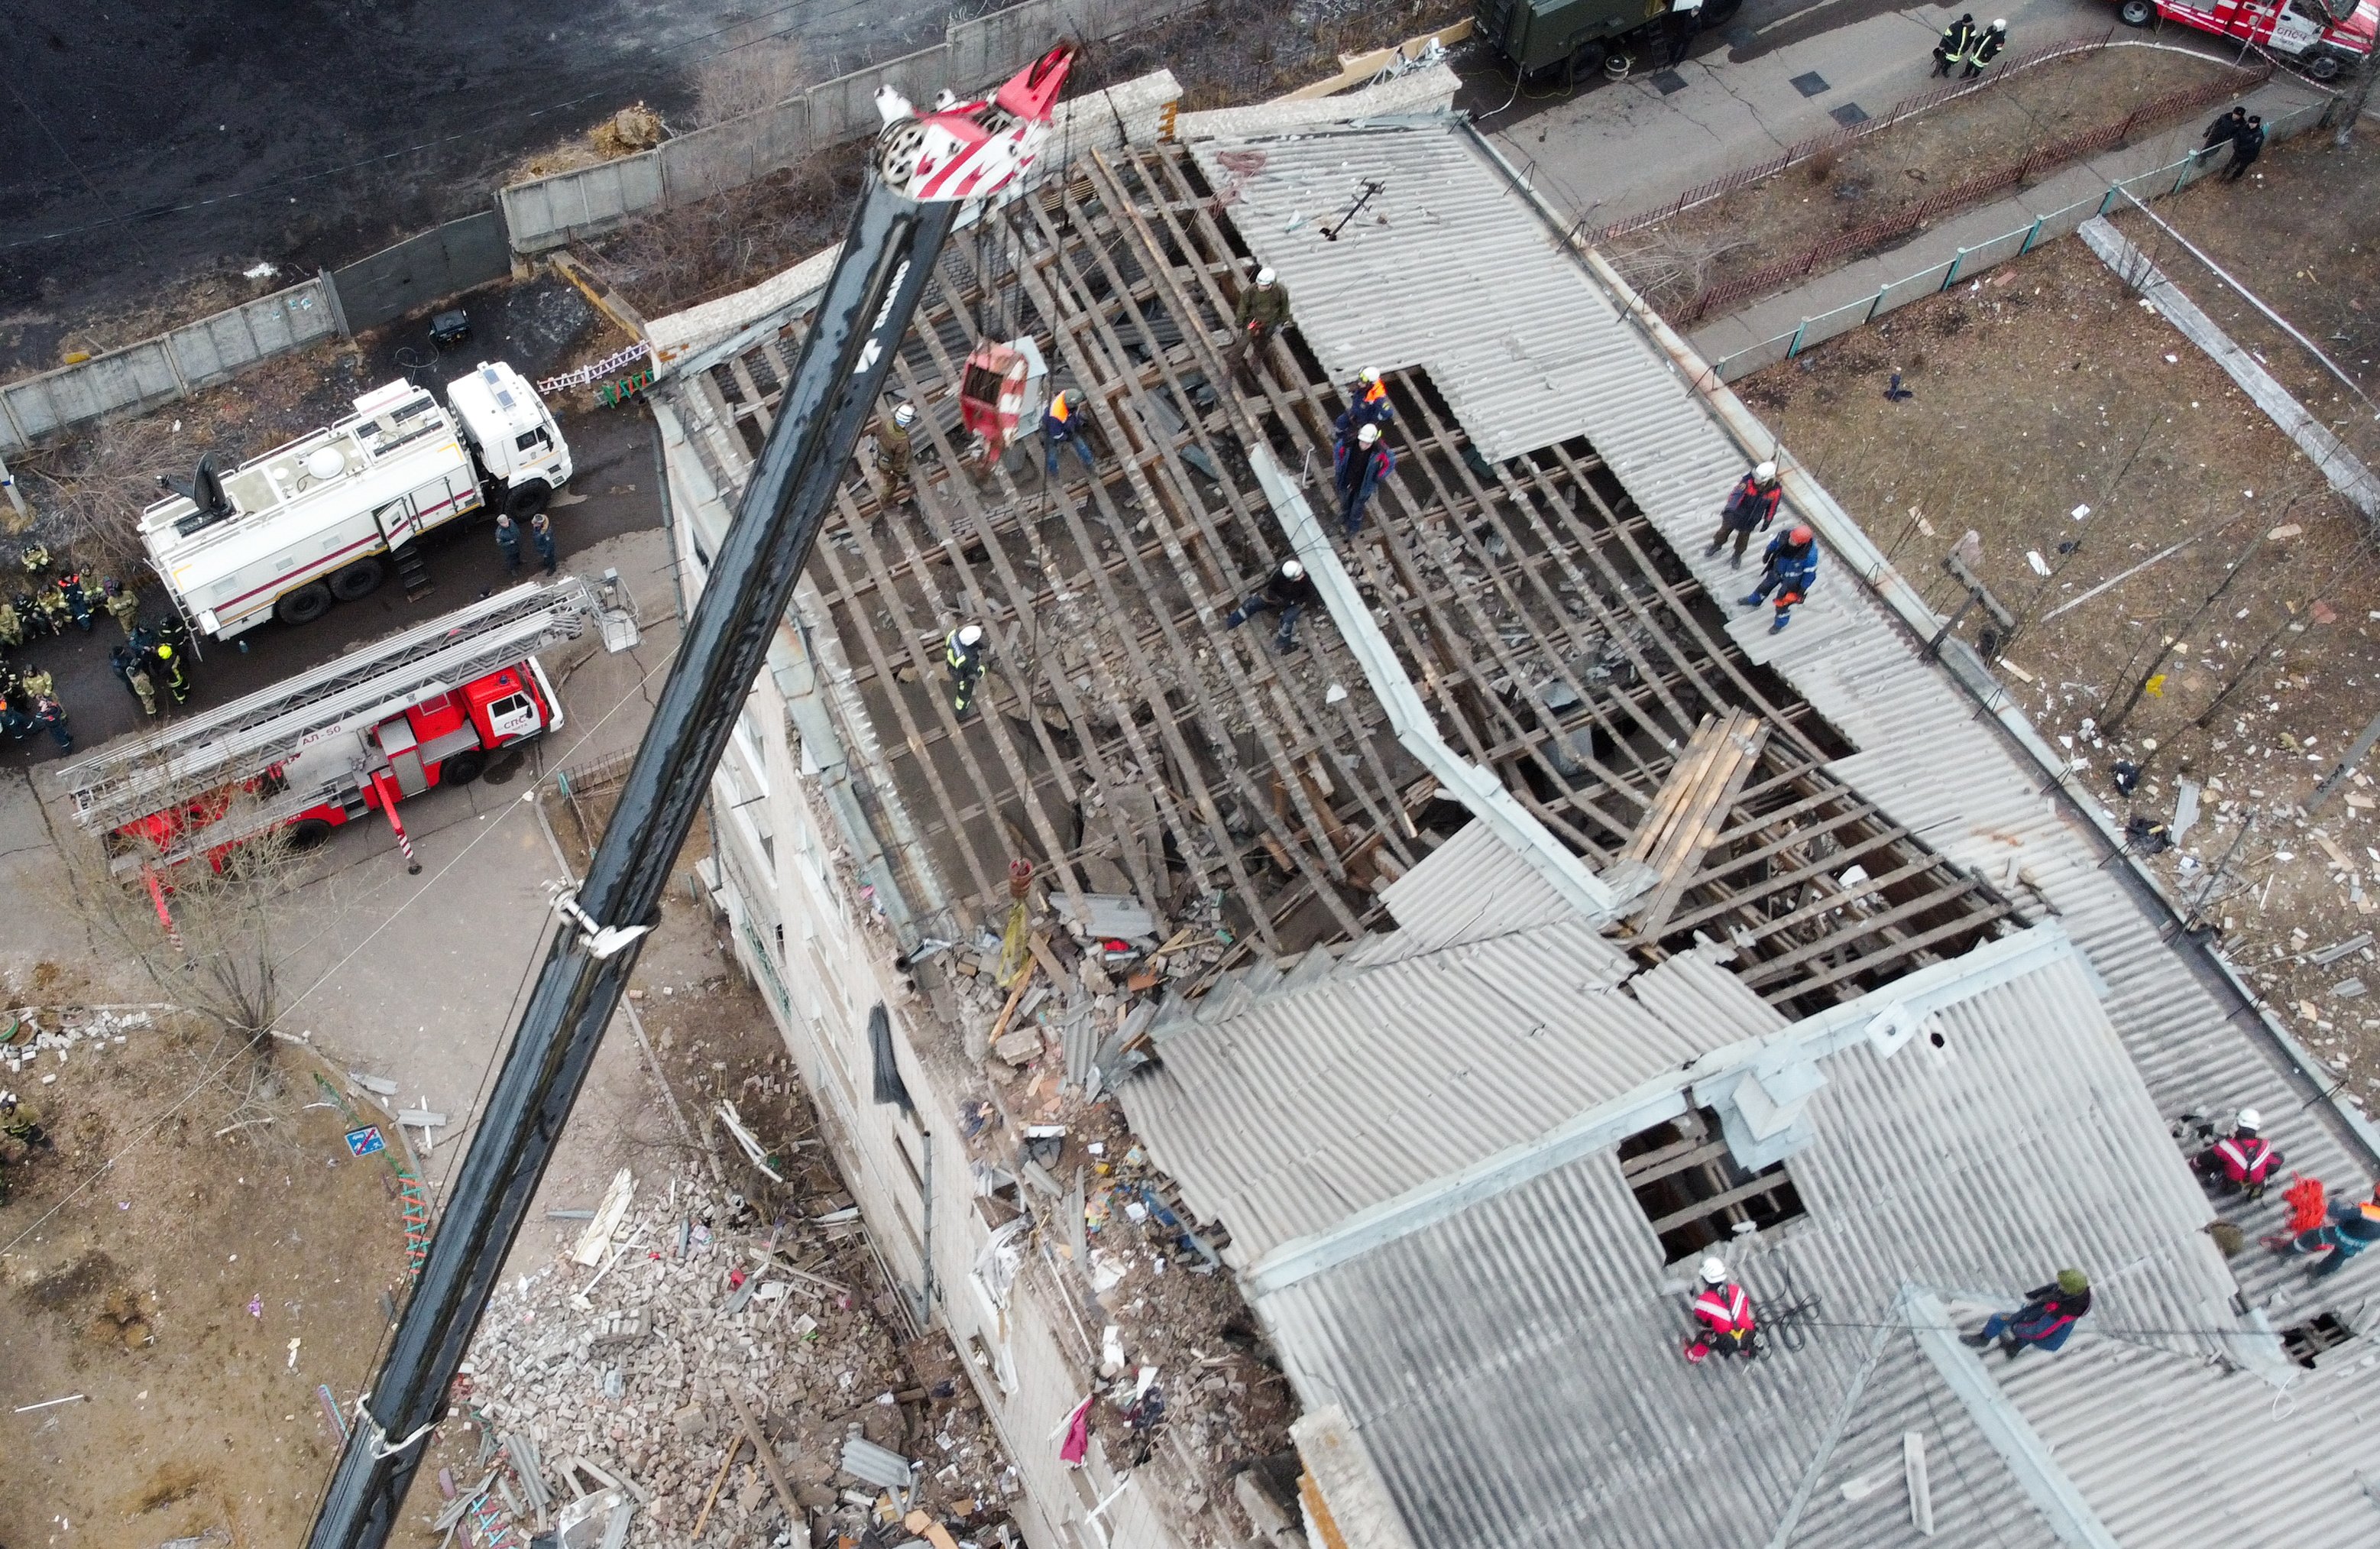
[0,0,966,374]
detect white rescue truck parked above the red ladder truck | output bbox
[141,361,572,640]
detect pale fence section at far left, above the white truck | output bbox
[0,278,338,452]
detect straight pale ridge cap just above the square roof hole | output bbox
[1242,921,2075,1301]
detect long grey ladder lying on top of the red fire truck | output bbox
[60,576,633,873]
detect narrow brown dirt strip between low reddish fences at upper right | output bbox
[1611,47,2237,307]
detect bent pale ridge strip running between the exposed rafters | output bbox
[1247,442,1626,921]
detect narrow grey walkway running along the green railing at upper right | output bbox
[1690,74,2323,361]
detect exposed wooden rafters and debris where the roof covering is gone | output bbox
[678,126,2009,1011]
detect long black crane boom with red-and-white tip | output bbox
[307,45,1073,1549]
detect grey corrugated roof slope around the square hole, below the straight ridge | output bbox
[1261,959,2273,1549]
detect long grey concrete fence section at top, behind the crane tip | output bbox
[497,0,1171,252]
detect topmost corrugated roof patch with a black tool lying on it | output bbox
[1190,124,1642,459]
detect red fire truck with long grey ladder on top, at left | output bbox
[62,571,636,880]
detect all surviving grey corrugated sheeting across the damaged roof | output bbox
[1125,115,2380,1549]
